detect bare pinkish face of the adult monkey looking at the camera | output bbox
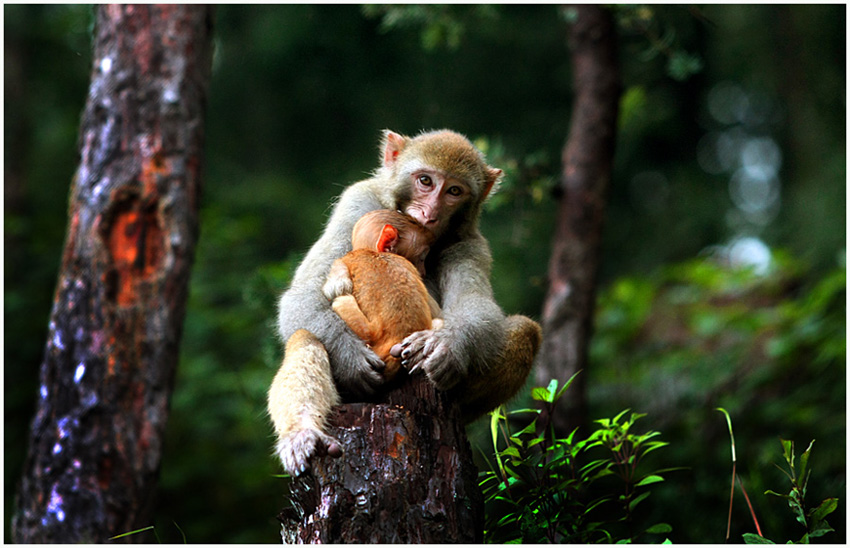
[404,170,472,238]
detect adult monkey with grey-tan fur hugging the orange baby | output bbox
[269,131,541,473]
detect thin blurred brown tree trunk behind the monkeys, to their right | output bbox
[537,5,621,436]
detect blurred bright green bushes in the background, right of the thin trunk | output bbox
[589,251,846,542]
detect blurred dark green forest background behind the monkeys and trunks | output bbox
[4,5,846,543]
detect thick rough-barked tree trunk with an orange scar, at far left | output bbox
[13,5,212,543]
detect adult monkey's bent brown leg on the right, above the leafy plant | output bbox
[458,315,543,422]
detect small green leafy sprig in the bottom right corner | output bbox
[744,439,838,544]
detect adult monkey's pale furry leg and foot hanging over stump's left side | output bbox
[268,329,342,476]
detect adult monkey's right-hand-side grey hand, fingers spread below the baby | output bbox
[390,326,467,390]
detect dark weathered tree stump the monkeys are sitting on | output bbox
[281,375,484,544]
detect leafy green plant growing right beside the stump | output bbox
[481,376,672,543]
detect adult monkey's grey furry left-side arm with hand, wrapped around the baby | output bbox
[278,183,385,396]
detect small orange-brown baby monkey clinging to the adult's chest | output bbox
[322,209,442,381]
